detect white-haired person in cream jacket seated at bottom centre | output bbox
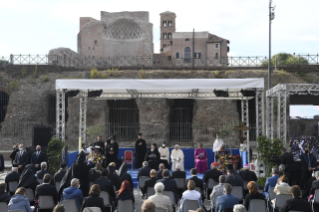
[148,183,173,212]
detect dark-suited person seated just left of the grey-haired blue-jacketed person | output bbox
[35,174,59,204]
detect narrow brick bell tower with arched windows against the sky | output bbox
[160,11,176,52]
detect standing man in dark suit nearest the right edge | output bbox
[300,148,316,189]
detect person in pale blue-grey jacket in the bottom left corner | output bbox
[8,187,33,212]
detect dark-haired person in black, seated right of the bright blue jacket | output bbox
[81,184,106,212]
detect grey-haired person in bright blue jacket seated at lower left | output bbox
[61,178,83,212]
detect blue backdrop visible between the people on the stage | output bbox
[67,147,247,169]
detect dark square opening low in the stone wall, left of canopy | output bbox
[32,125,53,147]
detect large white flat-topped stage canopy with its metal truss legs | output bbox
[56,78,265,162]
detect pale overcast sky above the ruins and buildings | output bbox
[0,0,319,57]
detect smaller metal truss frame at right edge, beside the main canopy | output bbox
[266,84,319,146]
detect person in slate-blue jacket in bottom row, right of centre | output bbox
[215,183,238,212]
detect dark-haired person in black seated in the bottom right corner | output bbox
[281,185,312,212]
